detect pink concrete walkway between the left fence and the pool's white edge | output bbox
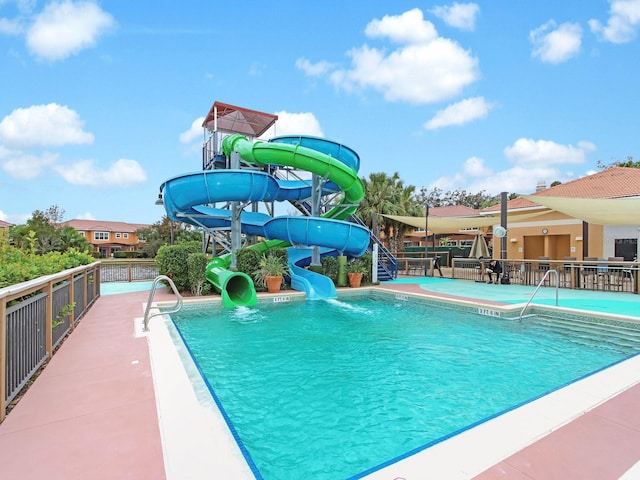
[0,290,175,480]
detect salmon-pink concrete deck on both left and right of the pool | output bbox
[0,285,640,480]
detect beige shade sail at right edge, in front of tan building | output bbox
[524,195,640,227]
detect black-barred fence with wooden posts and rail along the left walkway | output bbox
[0,262,100,421]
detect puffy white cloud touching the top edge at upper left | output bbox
[26,0,115,61]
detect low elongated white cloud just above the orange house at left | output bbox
[54,158,147,187]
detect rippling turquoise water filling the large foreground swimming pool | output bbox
[173,296,640,480]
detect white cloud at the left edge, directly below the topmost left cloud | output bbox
[0,103,93,147]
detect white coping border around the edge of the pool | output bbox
[142,286,640,480]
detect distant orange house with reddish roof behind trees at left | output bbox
[61,219,151,258]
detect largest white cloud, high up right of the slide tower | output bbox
[298,9,479,104]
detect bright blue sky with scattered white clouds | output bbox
[0,0,640,224]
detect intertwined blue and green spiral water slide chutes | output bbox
[161,136,370,305]
